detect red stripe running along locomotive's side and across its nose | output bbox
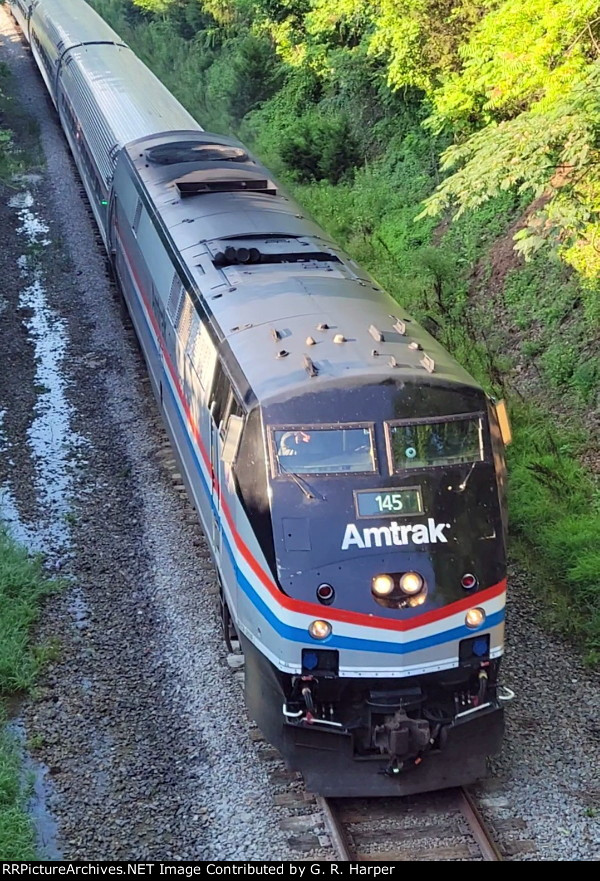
[117,227,506,630]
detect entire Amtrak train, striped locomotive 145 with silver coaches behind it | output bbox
[10,0,508,795]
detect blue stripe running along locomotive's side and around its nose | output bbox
[127,274,505,655]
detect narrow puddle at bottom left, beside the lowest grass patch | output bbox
[7,719,63,860]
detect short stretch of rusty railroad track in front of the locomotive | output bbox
[318,789,503,862]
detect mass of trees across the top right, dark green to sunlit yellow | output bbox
[96,0,600,279]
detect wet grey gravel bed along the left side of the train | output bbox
[0,8,308,860]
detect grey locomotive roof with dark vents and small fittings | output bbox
[126,132,477,401]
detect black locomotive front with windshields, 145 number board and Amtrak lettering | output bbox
[262,381,504,619]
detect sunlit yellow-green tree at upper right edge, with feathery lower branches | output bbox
[424,0,600,278]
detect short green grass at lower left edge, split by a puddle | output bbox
[0,526,57,860]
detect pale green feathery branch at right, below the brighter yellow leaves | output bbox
[425,62,600,275]
